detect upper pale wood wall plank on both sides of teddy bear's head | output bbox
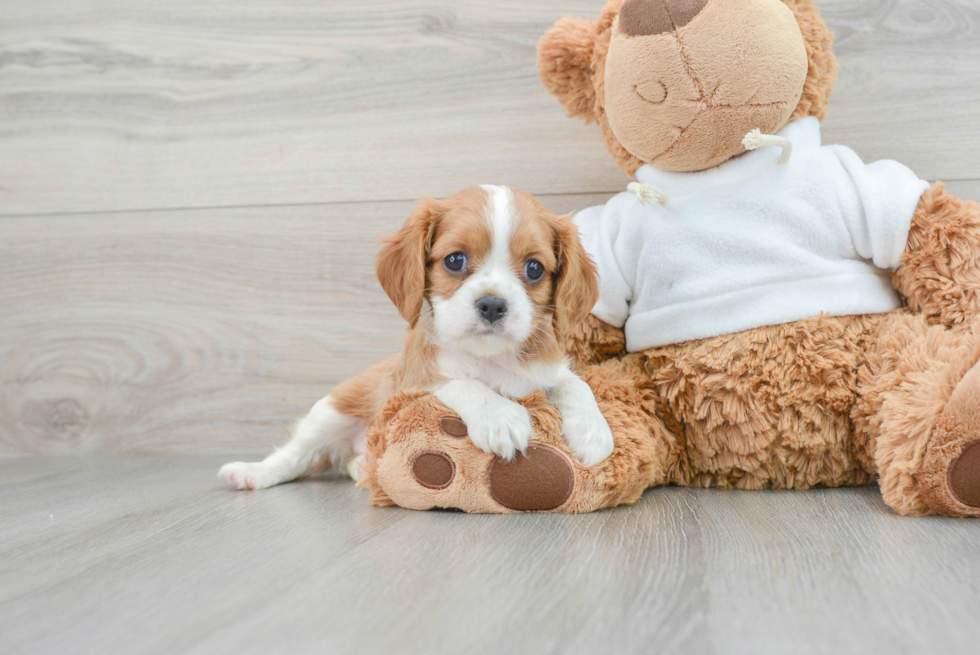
[0,0,980,215]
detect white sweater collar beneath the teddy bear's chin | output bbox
[636,116,821,198]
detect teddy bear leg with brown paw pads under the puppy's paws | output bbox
[360,361,676,513]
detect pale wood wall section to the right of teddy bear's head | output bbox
[817,0,980,174]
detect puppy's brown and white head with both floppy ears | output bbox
[378,186,599,356]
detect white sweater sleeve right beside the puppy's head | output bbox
[575,198,633,328]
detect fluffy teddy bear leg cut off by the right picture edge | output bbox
[854,314,980,517]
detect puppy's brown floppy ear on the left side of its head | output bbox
[377,198,445,327]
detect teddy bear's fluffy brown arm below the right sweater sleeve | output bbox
[892,182,980,328]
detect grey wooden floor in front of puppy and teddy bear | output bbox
[0,455,980,655]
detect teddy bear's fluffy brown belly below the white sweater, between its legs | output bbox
[627,310,884,489]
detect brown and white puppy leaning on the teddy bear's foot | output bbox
[219,186,613,489]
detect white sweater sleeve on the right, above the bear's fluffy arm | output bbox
[832,146,929,271]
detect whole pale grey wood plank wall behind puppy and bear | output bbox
[0,0,980,453]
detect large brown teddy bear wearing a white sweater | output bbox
[360,0,980,517]
